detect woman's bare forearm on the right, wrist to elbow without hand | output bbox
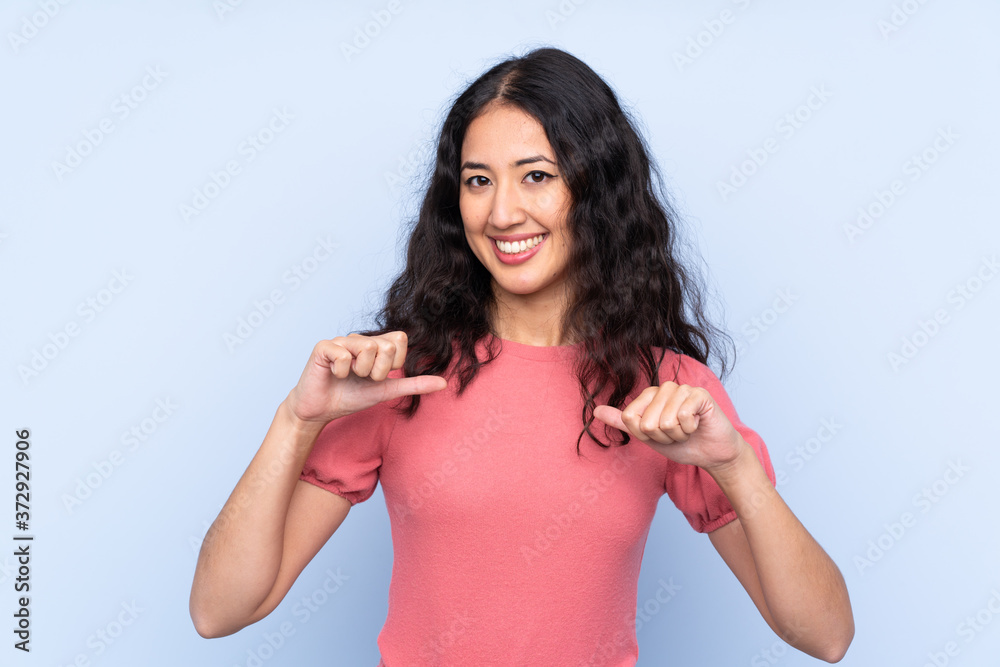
[708,438,854,662]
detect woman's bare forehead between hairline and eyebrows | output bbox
[462,103,555,162]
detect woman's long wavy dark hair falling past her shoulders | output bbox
[359,48,731,454]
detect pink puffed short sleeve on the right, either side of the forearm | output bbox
[660,355,775,533]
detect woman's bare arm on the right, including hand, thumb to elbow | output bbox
[594,382,854,662]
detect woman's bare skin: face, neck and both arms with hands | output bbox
[190,99,854,662]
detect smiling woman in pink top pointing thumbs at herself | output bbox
[191,49,854,667]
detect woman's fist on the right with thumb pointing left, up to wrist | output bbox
[594,382,748,473]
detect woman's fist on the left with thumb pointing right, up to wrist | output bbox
[285,331,448,425]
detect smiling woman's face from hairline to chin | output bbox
[458,104,571,314]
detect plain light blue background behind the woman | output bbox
[0,0,1000,667]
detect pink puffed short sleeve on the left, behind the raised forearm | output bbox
[299,401,398,505]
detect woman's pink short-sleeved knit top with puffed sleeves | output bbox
[301,340,774,667]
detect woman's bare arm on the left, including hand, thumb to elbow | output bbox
[190,331,447,637]
